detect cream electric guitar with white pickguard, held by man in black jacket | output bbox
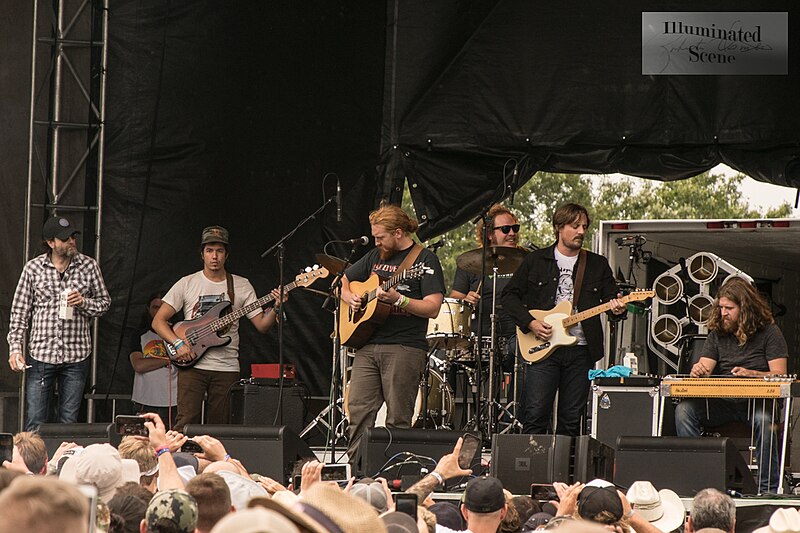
[517,289,655,363]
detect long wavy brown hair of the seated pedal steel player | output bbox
[708,277,775,346]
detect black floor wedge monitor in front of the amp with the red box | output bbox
[184,424,316,485]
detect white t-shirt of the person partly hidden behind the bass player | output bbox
[131,330,178,407]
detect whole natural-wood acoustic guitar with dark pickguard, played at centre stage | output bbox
[339,263,433,349]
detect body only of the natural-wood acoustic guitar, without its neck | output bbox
[339,274,392,349]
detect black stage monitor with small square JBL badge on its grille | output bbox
[492,434,572,494]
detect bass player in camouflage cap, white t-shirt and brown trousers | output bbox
[153,226,286,431]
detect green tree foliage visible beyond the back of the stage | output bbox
[404,172,791,283]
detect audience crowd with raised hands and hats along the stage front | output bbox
[0,426,800,533]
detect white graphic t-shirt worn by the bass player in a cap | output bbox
[163,270,262,372]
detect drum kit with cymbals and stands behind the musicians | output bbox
[301,241,527,444]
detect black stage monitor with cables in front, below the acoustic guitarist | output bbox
[354,427,481,486]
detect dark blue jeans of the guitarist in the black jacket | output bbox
[521,346,592,437]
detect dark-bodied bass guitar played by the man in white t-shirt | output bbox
[164,266,328,368]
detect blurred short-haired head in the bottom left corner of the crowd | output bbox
[0,475,89,533]
